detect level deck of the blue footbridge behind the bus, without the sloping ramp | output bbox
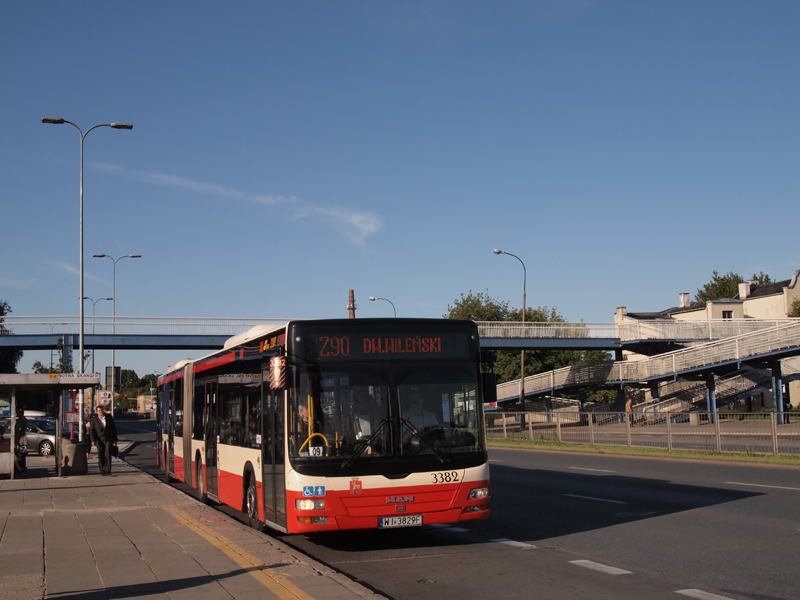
[0,315,793,355]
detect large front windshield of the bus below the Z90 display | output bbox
[289,361,486,473]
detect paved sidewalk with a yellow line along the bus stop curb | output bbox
[0,457,382,600]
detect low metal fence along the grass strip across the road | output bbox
[486,411,800,456]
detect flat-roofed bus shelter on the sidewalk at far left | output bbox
[0,373,100,479]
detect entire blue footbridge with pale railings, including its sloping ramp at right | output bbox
[0,316,800,412]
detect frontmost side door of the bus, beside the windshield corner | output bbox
[261,370,286,529]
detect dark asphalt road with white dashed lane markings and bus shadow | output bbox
[119,422,800,600]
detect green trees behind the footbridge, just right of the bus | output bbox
[443,290,608,383]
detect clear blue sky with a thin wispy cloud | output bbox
[0,0,800,375]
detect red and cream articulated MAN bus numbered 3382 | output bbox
[157,319,496,533]
